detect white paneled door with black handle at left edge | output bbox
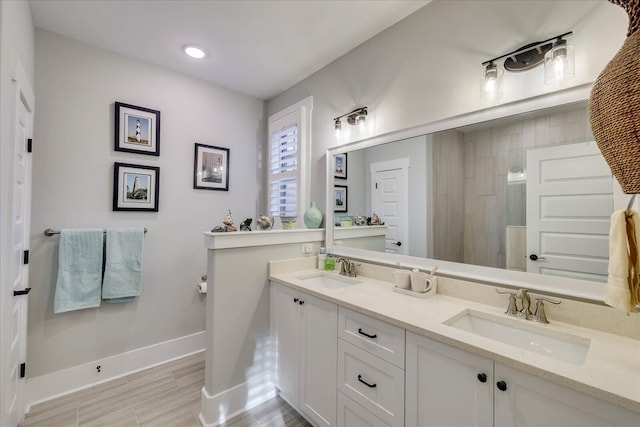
[0,63,34,426]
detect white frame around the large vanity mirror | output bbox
[325,83,605,304]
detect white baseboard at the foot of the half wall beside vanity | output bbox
[198,373,276,427]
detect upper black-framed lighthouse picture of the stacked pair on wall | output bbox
[114,102,160,156]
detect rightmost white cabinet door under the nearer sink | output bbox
[494,363,640,427]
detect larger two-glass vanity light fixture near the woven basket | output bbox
[482,31,575,98]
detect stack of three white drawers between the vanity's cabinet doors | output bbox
[338,307,405,427]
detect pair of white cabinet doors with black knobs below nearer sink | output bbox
[406,332,640,427]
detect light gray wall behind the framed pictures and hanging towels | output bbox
[27,30,266,376]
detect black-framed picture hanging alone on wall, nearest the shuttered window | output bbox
[193,144,229,191]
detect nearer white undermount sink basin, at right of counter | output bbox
[444,310,591,365]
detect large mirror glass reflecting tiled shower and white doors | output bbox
[334,103,614,282]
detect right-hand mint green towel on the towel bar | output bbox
[102,228,144,302]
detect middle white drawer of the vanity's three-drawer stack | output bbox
[338,339,404,426]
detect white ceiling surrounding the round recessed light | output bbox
[29,0,430,99]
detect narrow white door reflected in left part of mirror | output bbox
[369,159,409,255]
